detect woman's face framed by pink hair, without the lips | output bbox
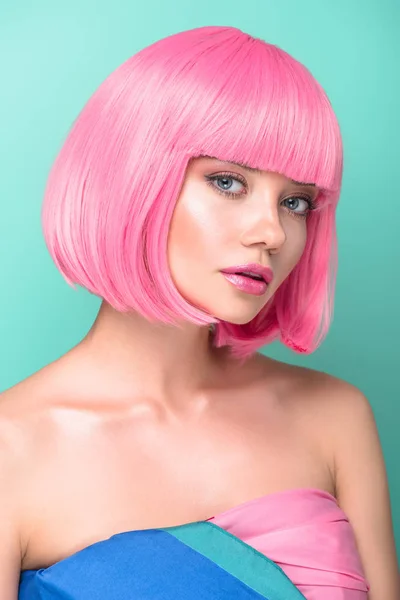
[168,157,319,325]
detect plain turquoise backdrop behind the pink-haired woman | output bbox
[0,0,400,548]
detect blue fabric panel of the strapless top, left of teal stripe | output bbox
[18,523,303,600]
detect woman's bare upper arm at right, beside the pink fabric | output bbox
[330,382,400,600]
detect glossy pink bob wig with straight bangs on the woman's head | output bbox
[42,26,343,360]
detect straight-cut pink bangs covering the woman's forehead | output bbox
[178,37,343,199]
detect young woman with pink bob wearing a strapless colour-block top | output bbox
[0,27,400,600]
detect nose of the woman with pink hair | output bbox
[241,206,286,254]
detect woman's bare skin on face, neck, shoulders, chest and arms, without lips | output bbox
[0,157,400,600]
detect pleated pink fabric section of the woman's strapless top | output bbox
[208,488,369,600]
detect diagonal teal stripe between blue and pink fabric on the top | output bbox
[163,521,305,600]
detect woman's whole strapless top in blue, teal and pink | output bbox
[18,488,369,600]
